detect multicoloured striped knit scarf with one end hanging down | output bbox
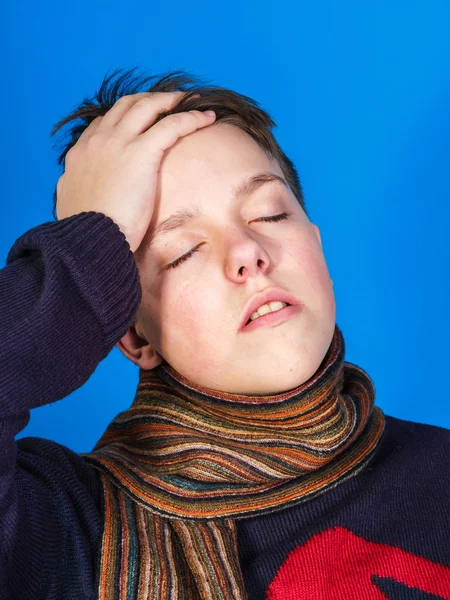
[82,325,384,600]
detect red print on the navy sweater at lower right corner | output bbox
[266,527,450,600]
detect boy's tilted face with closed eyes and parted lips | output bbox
[118,122,336,395]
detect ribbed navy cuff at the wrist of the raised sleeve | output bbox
[7,211,142,349]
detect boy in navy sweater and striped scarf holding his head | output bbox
[0,68,450,600]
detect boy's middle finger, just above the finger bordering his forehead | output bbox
[116,92,196,140]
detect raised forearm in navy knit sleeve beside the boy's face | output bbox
[0,213,141,418]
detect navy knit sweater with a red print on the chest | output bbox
[0,212,450,600]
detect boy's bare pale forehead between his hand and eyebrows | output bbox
[140,123,287,253]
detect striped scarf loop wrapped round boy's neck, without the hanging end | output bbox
[84,326,384,518]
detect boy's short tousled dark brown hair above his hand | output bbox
[51,67,307,220]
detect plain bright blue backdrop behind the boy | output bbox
[0,0,450,452]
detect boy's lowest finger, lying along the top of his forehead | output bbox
[139,110,216,164]
